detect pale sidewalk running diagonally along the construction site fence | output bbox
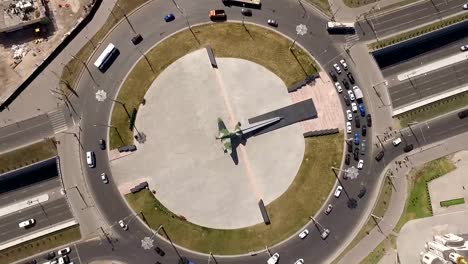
[0,0,115,126]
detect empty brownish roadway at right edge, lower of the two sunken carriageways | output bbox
[388,61,468,108]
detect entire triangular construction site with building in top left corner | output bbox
[0,0,94,101]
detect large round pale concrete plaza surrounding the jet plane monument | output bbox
[112,49,304,229]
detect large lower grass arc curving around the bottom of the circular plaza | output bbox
[125,133,343,255]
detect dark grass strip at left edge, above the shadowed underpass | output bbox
[0,139,57,173]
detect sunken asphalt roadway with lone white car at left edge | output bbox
[0,198,73,242]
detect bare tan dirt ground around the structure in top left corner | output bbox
[0,0,91,101]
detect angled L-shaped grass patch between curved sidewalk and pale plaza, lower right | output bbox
[394,157,456,233]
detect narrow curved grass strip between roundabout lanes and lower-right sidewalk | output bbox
[332,174,393,264]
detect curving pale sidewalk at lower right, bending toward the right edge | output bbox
[339,132,468,263]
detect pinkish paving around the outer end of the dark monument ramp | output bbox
[290,72,344,132]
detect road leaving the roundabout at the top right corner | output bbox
[356,0,466,41]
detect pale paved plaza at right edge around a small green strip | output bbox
[428,151,468,215]
